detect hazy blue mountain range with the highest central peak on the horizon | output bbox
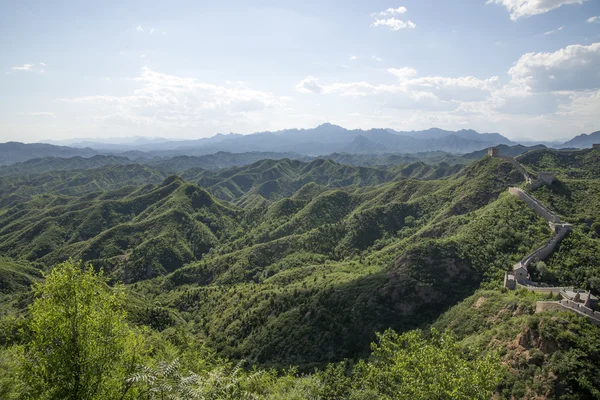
[38,124,515,158]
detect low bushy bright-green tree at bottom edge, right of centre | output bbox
[354,330,503,400]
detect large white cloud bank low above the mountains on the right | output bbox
[298,43,600,140]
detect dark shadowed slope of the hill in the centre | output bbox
[237,252,479,371]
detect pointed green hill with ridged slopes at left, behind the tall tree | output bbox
[0,177,238,281]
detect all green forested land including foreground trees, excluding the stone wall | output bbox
[0,148,600,399]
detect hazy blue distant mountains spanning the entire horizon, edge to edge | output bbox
[0,124,600,164]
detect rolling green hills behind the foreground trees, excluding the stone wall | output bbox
[0,149,600,398]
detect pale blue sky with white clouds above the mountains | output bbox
[0,0,600,142]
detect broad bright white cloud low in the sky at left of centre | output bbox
[65,67,290,130]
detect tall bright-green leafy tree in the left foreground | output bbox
[21,261,143,400]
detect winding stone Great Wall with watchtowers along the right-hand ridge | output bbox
[488,148,600,325]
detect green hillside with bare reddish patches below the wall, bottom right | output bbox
[434,290,600,399]
